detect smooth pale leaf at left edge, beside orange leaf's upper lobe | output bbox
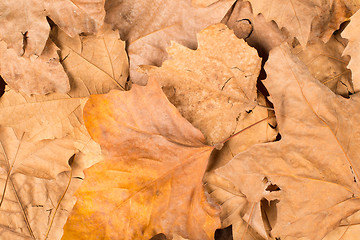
[0,89,87,141]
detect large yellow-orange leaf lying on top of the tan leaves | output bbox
[63,80,219,240]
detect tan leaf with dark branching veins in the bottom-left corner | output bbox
[0,168,80,240]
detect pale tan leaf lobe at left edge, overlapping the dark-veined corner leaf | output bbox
[0,127,75,179]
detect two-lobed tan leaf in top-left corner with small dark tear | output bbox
[0,0,105,57]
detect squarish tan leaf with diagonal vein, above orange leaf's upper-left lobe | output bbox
[51,24,129,97]
